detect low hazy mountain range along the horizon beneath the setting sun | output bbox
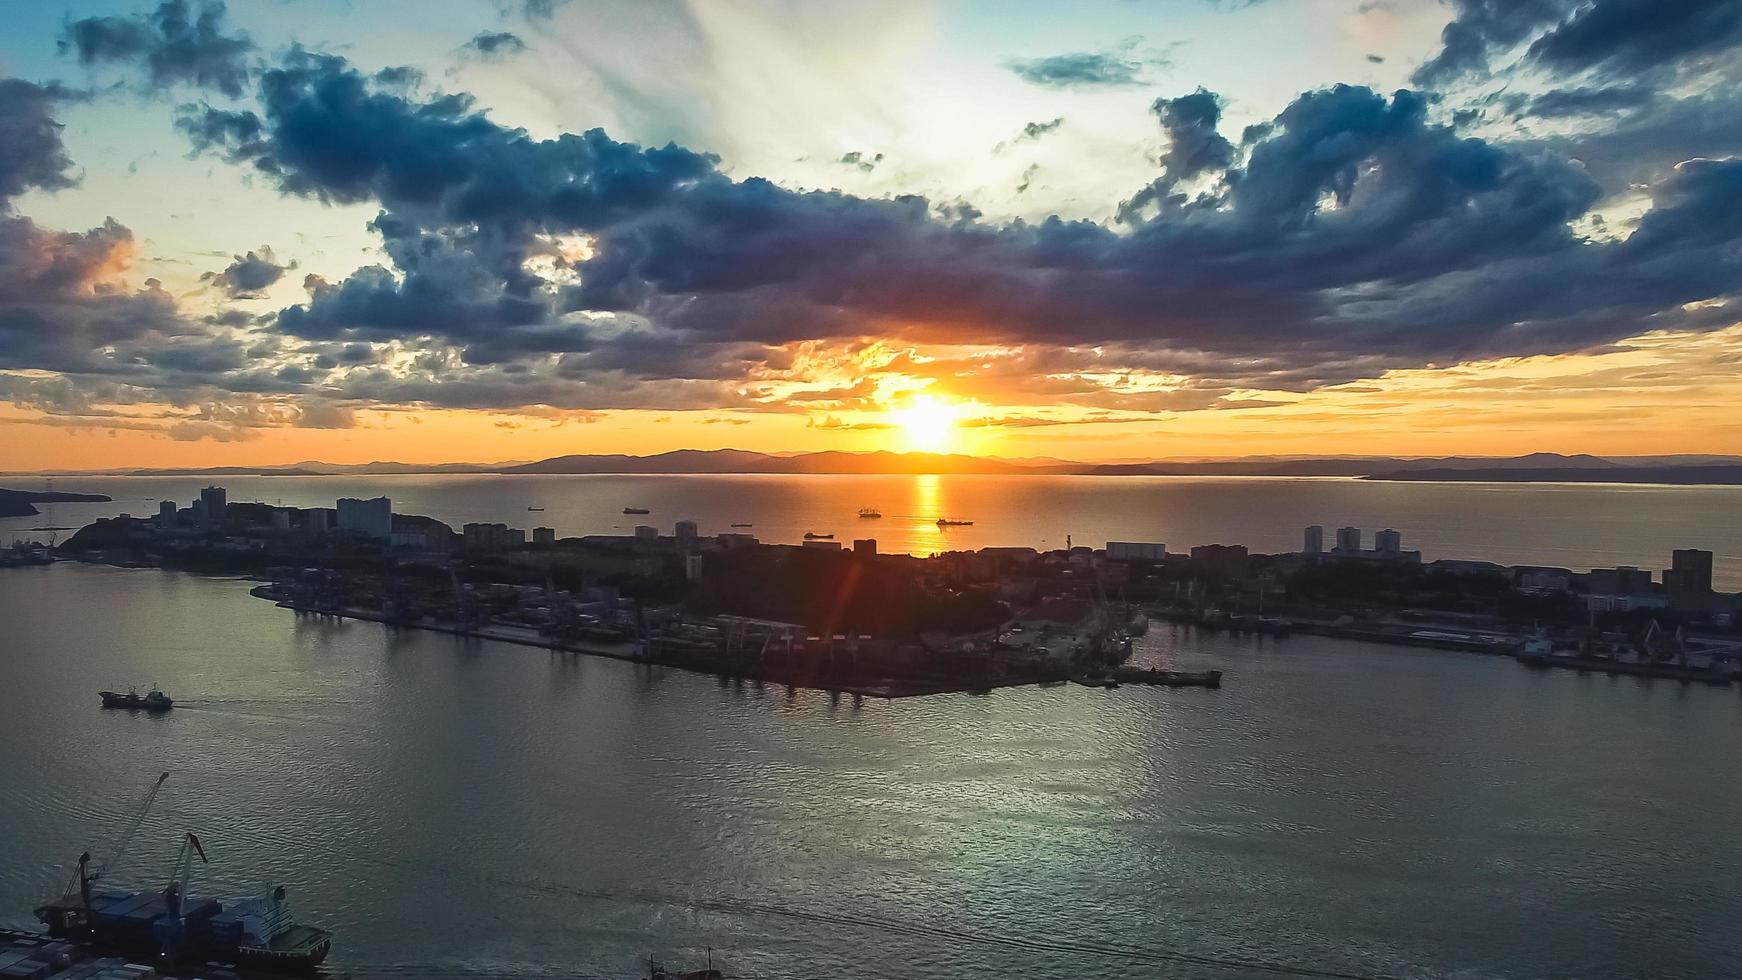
[10,449,1742,484]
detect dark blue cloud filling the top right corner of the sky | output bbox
[1415,0,1742,85]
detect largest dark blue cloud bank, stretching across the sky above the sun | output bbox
[169,47,1737,376]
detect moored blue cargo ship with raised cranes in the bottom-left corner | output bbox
[37,773,333,971]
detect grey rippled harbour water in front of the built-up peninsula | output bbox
[0,564,1742,980]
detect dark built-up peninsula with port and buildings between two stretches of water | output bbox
[40,487,1742,696]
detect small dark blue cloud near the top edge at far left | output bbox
[59,0,254,97]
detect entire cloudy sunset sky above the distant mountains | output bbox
[0,0,1742,470]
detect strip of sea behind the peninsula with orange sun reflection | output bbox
[0,475,1742,590]
